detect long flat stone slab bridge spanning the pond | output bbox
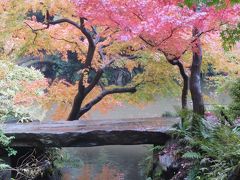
[3,118,178,147]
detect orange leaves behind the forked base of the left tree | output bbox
[41,80,121,120]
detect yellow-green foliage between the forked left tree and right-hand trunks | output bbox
[117,51,182,104]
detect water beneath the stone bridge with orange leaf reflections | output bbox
[62,145,151,180]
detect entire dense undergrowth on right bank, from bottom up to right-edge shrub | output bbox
[150,80,240,180]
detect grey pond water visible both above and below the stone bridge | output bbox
[54,98,180,180]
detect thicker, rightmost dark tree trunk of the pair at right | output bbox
[190,28,204,116]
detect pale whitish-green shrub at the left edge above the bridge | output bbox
[0,61,44,121]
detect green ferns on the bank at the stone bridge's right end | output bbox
[172,107,240,180]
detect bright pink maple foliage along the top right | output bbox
[72,0,240,57]
